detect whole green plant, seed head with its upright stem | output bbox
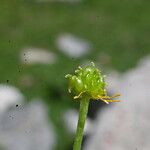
[66,62,119,150]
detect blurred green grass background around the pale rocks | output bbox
[0,0,150,150]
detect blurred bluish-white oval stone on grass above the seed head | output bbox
[56,34,91,58]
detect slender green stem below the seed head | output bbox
[73,98,89,150]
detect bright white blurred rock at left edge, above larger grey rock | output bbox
[0,84,24,113]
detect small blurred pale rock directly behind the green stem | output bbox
[64,110,92,134]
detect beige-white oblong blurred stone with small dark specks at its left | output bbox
[20,48,57,64]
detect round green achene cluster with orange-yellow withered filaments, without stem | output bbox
[66,62,119,103]
